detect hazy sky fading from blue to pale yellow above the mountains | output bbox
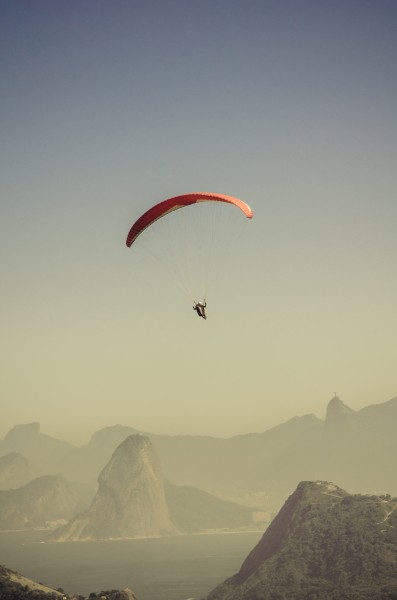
[0,0,397,443]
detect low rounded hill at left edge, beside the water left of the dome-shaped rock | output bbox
[0,475,90,531]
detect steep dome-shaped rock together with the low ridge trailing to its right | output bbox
[48,434,253,542]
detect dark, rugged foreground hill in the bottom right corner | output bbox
[207,481,397,600]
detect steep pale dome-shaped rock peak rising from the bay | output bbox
[51,435,176,542]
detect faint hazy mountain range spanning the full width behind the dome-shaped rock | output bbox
[0,396,397,511]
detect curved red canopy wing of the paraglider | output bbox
[126,192,253,247]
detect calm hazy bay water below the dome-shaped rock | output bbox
[0,532,262,600]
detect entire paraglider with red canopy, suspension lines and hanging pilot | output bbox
[126,192,253,319]
